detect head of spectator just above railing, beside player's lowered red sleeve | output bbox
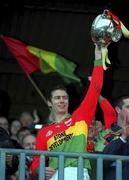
[22,134,36,150]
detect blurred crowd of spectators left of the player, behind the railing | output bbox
[0,110,40,180]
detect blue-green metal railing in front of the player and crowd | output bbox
[0,148,129,180]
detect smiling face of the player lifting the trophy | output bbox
[49,90,69,114]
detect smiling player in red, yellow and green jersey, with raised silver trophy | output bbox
[32,10,129,180]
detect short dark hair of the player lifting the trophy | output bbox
[47,84,68,101]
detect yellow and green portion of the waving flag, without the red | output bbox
[28,46,80,83]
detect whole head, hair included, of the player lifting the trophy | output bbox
[48,85,69,115]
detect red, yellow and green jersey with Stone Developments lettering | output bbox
[32,60,103,174]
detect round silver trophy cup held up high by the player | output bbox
[91,10,122,46]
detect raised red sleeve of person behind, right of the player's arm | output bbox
[99,96,117,129]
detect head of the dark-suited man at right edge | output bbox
[115,96,129,126]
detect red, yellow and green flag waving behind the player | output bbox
[0,36,80,83]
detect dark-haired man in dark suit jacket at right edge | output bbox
[104,96,129,180]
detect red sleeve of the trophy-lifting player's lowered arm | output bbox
[31,130,47,176]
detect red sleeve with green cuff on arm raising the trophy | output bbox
[72,59,104,126]
